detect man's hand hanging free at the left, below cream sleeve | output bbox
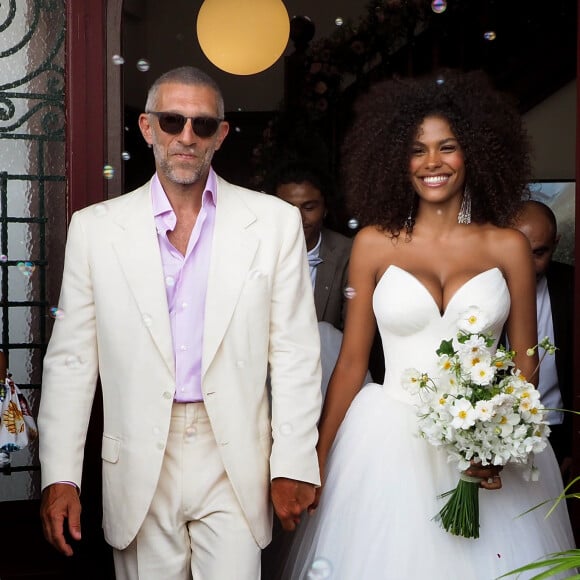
[40,483,81,556]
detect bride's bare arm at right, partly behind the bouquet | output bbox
[501,230,536,385]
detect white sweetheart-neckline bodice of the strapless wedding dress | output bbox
[373,265,510,402]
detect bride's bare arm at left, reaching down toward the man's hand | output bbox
[318,228,385,475]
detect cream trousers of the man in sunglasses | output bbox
[113,403,260,580]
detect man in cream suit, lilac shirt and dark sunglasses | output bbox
[39,67,321,580]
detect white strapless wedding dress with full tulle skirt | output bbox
[285,266,574,580]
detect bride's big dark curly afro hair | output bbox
[341,70,531,235]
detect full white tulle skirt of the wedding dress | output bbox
[284,384,574,580]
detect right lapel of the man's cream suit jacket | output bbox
[202,178,258,375]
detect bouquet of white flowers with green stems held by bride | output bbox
[403,307,555,538]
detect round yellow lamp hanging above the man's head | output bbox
[197,0,290,75]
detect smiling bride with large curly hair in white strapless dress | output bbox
[285,72,574,580]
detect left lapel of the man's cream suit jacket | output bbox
[113,184,175,375]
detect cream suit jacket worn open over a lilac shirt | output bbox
[38,178,321,549]
